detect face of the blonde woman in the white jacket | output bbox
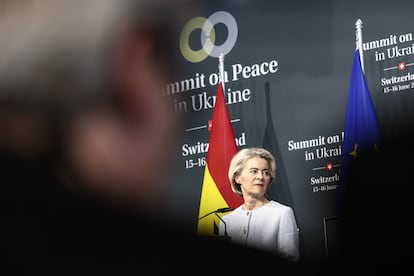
[235,157,271,198]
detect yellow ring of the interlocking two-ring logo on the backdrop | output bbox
[180,16,216,63]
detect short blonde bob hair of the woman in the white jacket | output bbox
[228,147,276,196]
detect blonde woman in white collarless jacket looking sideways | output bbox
[219,147,299,262]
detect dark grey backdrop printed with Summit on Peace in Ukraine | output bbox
[161,0,414,263]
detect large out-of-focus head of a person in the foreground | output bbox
[0,0,181,211]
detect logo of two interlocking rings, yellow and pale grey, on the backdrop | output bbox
[180,11,238,63]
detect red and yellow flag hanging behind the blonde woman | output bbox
[197,82,242,236]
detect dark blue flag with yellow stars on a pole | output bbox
[338,49,381,217]
